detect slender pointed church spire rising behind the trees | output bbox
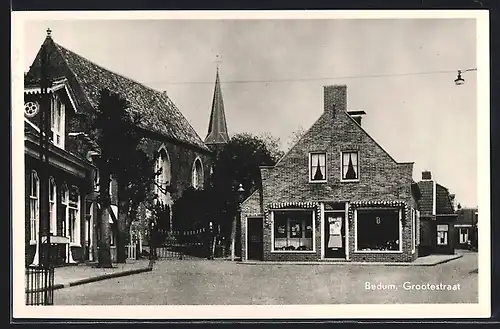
[205,56,229,146]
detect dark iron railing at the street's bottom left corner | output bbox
[25,266,54,306]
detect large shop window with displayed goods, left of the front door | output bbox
[273,210,314,251]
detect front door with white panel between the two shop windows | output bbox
[324,212,346,259]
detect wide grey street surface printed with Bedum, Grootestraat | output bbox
[54,253,478,305]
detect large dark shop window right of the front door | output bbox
[355,208,401,252]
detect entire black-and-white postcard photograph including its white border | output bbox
[12,10,490,319]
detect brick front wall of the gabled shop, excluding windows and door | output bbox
[242,85,418,262]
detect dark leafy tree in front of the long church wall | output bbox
[91,89,156,267]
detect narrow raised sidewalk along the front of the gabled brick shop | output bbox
[238,254,463,266]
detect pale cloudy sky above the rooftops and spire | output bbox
[22,19,478,207]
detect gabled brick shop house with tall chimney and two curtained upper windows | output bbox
[240,85,420,262]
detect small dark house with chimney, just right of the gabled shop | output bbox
[418,171,457,255]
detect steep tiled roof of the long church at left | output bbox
[25,37,208,151]
